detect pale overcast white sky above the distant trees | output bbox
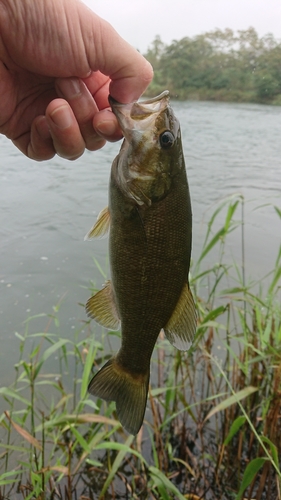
[83,0,281,53]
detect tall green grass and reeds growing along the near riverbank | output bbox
[0,196,281,500]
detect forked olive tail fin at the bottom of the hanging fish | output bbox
[88,357,149,435]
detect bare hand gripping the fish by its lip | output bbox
[0,0,153,161]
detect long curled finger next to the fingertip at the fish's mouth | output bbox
[56,78,104,151]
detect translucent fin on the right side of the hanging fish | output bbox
[164,283,197,351]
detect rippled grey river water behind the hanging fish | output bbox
[0,102,281,385]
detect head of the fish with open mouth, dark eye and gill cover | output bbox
[109,90,185,206]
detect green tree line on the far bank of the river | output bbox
[144,28,281,105]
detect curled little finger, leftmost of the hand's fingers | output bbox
[27,116,56,161]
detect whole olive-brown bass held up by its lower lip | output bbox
[85,91,197,435]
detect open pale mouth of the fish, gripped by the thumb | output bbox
[108,90,169,140]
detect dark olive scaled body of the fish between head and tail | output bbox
[109,154,191,372]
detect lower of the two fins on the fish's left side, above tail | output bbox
[85,281,121,330]
